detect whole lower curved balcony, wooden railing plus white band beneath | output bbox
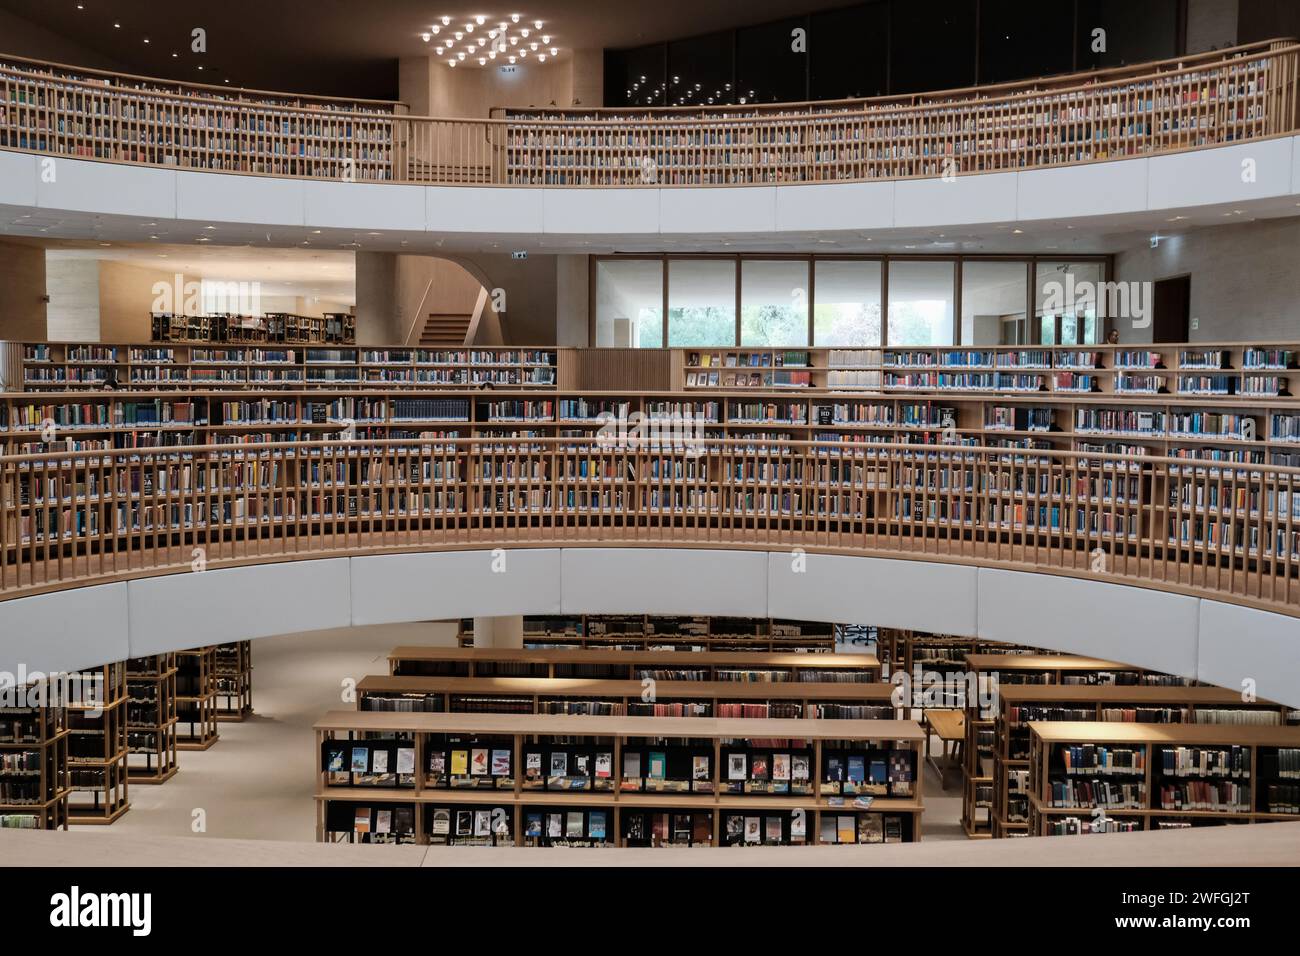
[0,438,1300,702]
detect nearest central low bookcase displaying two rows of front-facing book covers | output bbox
[316,711,923,845]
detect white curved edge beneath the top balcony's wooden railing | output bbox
[0,135,1300,239]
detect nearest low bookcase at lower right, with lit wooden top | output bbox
[1028,721,1300,836]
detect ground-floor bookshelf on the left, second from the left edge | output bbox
[68,661,131,825]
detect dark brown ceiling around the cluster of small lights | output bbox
[0,0,850,99]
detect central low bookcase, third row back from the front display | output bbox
[389,645,880,684]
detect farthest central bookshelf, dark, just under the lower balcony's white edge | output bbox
[458,614,835,653]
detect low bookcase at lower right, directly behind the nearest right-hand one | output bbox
[992,684,1300,836]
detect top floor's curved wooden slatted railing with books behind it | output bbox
[0,40,1300,186]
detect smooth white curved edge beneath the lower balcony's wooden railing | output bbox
[0,546,1300,706]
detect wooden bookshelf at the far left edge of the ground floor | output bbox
[0,697,70,830]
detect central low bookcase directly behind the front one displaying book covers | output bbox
[356,676,900,721]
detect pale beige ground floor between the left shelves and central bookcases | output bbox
[89,624,965,842]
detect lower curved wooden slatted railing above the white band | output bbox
[0,436,1300,617]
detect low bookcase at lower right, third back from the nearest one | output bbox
[959,653,1195,839]
